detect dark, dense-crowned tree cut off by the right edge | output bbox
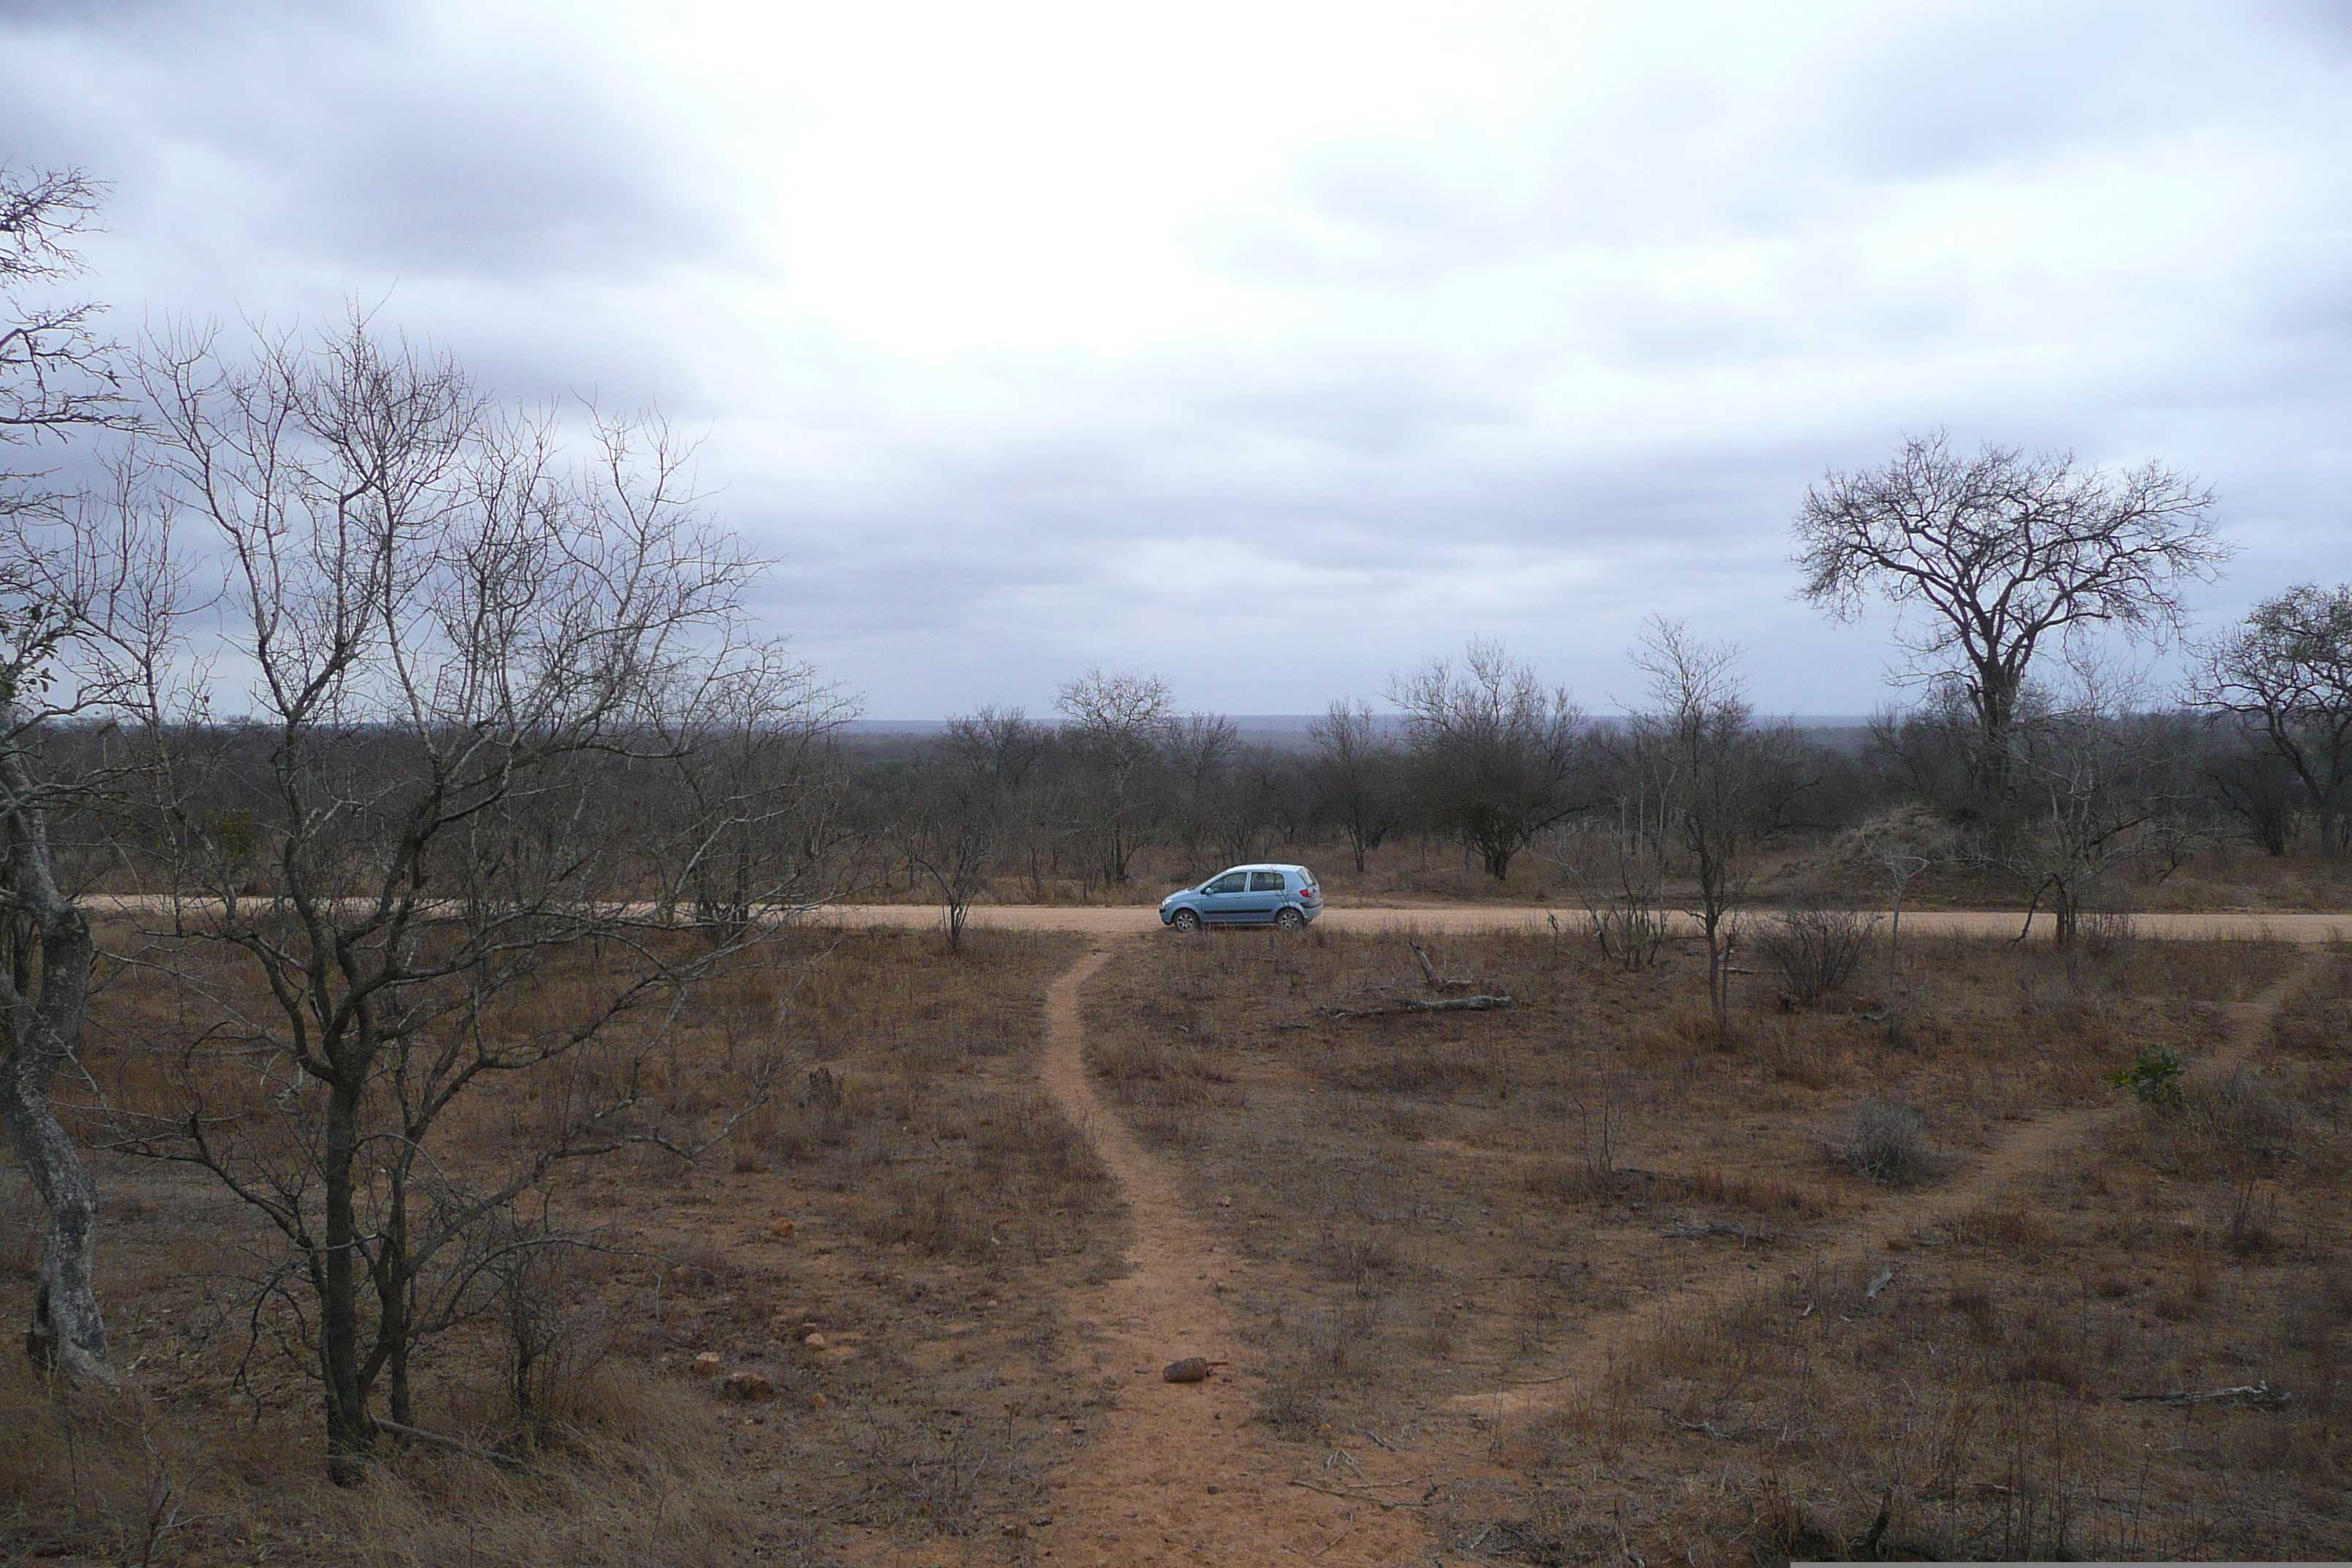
[2192,583,2352,853]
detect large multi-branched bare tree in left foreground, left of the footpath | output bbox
[116,320,832,1479]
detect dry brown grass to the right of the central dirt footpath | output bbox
[1089,933,2352,1564]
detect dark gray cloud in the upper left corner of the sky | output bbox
[0,2,727,287]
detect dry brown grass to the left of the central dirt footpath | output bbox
[0,933,1120,1568]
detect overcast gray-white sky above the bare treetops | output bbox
[0,0,2352,717]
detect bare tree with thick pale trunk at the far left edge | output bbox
[0,167,149,1382]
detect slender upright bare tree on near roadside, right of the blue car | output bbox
[1625,621,1797,1032]
